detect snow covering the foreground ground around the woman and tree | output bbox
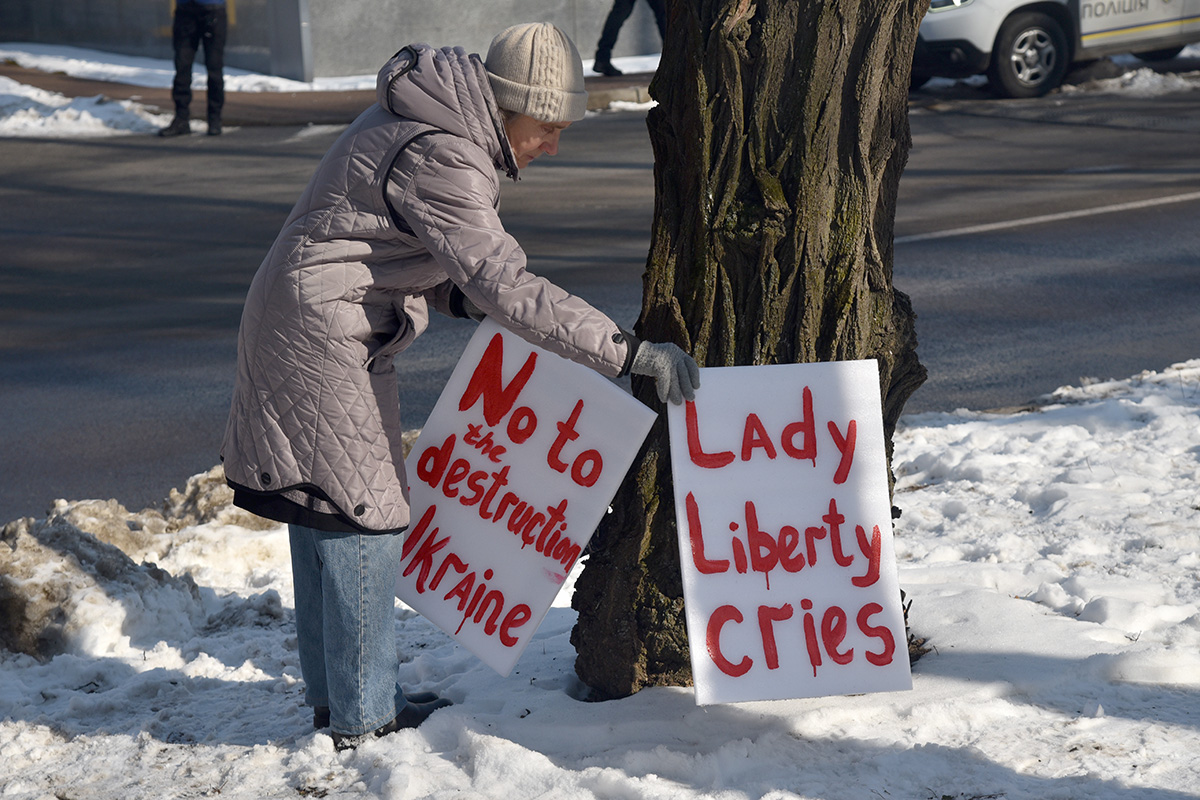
[0,360,1200,800]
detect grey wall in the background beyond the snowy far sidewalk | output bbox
[0,0,662,79]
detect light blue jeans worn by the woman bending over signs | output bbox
[288,525,407,735]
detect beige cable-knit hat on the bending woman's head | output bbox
[484,23,588,122]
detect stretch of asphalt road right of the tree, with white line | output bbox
[894,88,1200,411]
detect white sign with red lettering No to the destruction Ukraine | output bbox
[396,320,655,675]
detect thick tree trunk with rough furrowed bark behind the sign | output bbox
[571,0,928,698]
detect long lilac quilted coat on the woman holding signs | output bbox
[221,46,634,531]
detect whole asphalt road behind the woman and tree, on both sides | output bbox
[0,87,1200,521]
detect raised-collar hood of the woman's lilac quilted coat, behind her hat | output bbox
[376,44,517,180]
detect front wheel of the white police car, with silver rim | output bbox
[988,12,1070,97]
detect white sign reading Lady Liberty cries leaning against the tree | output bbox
[668,361,912,705]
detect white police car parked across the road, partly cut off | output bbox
[912,0,1200,97]
